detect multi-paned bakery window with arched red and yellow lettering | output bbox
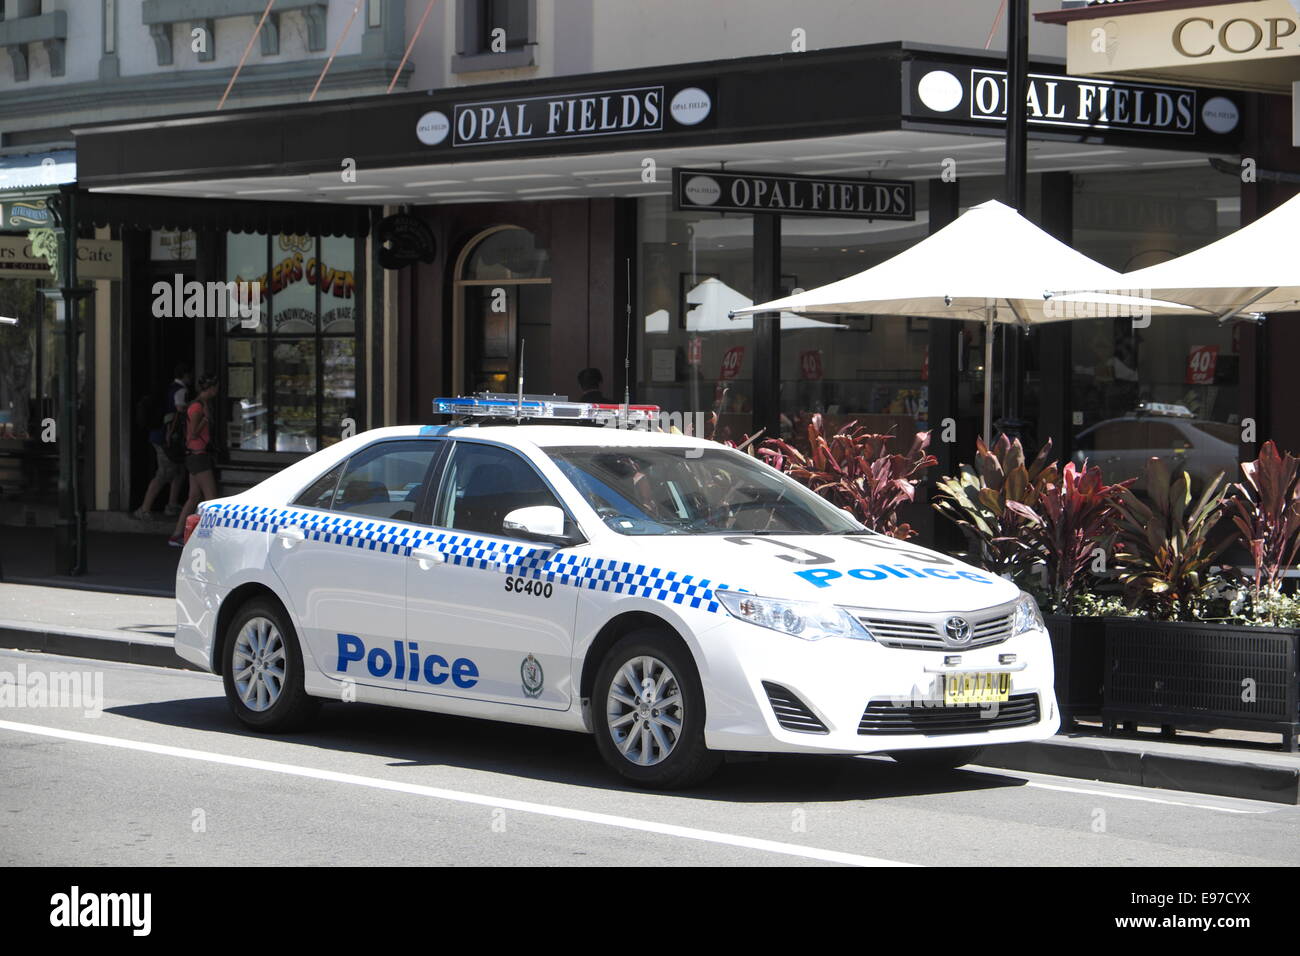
[221,233,358,453]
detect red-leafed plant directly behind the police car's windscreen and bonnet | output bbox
[758,415,939,538]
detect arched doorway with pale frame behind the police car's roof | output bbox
[452,225,553,394]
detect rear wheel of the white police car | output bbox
[221,597,321,734]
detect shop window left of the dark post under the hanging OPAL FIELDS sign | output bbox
[634,196,768,441]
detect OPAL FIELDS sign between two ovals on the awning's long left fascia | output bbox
[415,85,714,147]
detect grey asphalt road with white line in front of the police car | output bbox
[0,650,1300,866]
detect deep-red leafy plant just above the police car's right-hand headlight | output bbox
[1006,462,1131,614]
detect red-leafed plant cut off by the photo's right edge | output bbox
[1229,441,1300,600]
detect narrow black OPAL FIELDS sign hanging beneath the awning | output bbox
[672,169,917,221]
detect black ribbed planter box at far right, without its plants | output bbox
[1101,618,1300,752]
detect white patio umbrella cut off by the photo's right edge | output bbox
[1122,196,1300,320]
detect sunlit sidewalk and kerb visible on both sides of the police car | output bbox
[0,580,1300,805]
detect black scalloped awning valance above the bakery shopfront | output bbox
[77,193,371,237]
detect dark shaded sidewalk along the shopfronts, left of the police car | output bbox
[0,520,181,597]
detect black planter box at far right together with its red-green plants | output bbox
[1102,460,1300,750]
